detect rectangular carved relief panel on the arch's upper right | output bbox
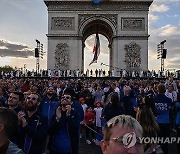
[121,18,145,31]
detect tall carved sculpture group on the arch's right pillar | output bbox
[124,42,141,68]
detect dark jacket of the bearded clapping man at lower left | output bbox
[18,112,48,154]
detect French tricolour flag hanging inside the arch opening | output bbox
[89,33,100,66]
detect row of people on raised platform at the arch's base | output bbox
[0,68,180,78]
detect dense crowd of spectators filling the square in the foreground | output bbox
[0,76,180,154]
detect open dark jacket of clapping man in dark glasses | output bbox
[48,108,80,154]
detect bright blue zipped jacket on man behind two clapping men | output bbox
[40,96,59,123]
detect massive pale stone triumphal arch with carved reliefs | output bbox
[44,0,153,74]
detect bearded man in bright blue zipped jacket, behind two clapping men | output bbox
[41,86,59,122]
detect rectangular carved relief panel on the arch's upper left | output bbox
[51,17,75,30]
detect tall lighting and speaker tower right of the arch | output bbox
[157,40,167,72]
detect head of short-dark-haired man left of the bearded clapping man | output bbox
[8,91,24,113]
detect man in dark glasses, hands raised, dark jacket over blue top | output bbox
[48,93,81,154]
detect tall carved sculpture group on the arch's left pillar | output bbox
[55,43,69,70]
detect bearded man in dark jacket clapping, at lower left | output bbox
[18,93,48,154]
